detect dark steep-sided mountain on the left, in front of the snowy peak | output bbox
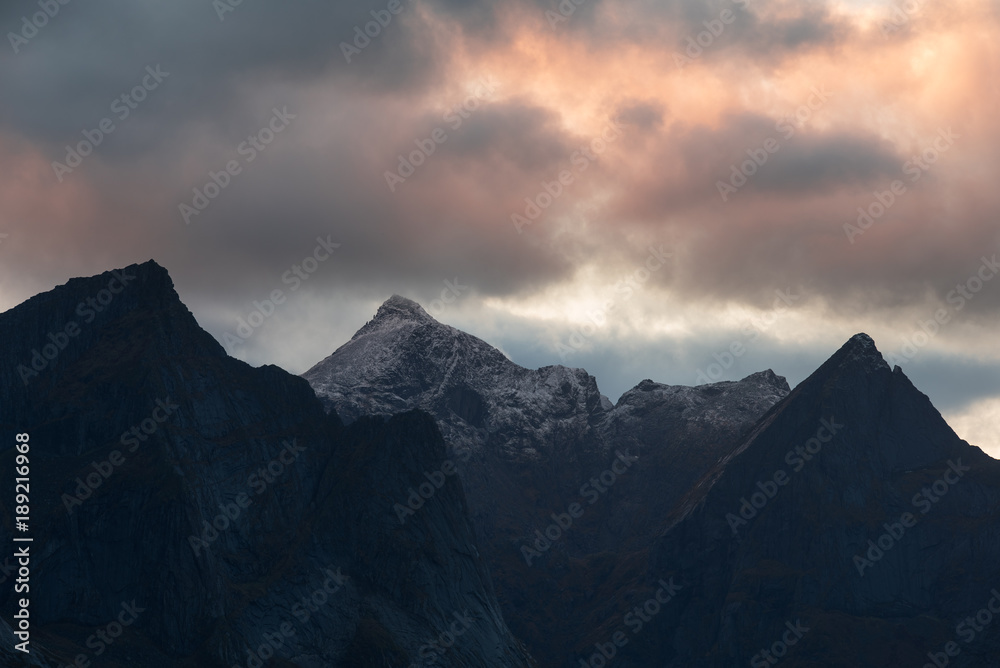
[0,262,531,668]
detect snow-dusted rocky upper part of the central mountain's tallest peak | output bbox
[303,296,606,463]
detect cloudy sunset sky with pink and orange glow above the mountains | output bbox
[0,0,1000,456]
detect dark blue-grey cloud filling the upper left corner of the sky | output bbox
[0,0,443,149]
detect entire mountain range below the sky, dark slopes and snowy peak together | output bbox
[0,262,1000,668]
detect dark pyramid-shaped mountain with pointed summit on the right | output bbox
[617,334,1000,668]
